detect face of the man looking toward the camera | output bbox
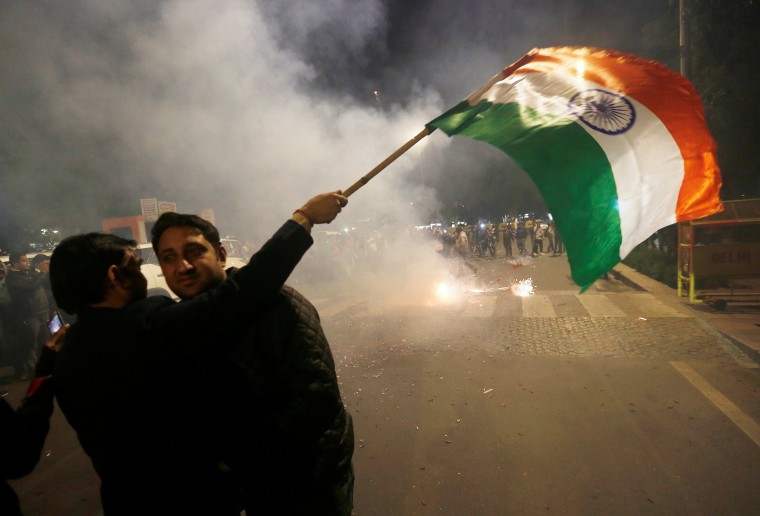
[157,227,227,299]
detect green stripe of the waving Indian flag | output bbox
[427,100,622,291]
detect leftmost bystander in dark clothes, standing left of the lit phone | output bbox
[5,251,49,381]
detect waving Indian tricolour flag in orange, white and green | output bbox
[427,47,723,290]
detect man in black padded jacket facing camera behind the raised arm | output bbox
[151,213,354,516]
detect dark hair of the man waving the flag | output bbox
[50,233,137,314]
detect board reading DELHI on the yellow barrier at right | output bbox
[693,242,760,276]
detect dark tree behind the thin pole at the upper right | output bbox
[643,0,760,199]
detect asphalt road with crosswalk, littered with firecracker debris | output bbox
[9,245,760,516]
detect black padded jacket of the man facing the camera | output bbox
[228,278,354,516]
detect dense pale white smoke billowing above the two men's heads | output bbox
[3,0,458,296]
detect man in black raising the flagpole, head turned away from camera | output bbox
[50,192,348,516]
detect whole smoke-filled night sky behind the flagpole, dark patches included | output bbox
[0,0,667,298]
